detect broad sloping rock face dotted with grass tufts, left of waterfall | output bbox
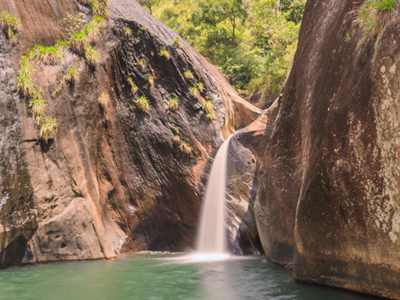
[0,0,261,268]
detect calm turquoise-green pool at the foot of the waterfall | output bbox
[0,254,380,300]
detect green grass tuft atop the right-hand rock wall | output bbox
[355,0,398,35]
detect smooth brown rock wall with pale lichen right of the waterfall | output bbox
[255,0,400,299]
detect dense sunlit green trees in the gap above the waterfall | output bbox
[139,0,306,94]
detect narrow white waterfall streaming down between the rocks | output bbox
[191,136,232,259]
